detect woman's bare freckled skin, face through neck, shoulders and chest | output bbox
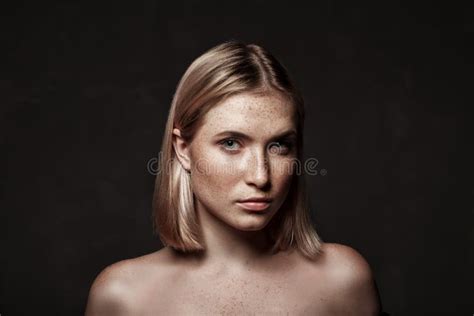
[86,93,380,316]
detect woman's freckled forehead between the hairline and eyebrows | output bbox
[200,93,296,136]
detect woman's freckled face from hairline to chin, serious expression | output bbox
[176,93,297,231]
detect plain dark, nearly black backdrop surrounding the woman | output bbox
[0,0,474,316]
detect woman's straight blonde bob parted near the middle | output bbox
[152,40,321,259]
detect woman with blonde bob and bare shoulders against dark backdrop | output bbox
[86,42,380,316]
